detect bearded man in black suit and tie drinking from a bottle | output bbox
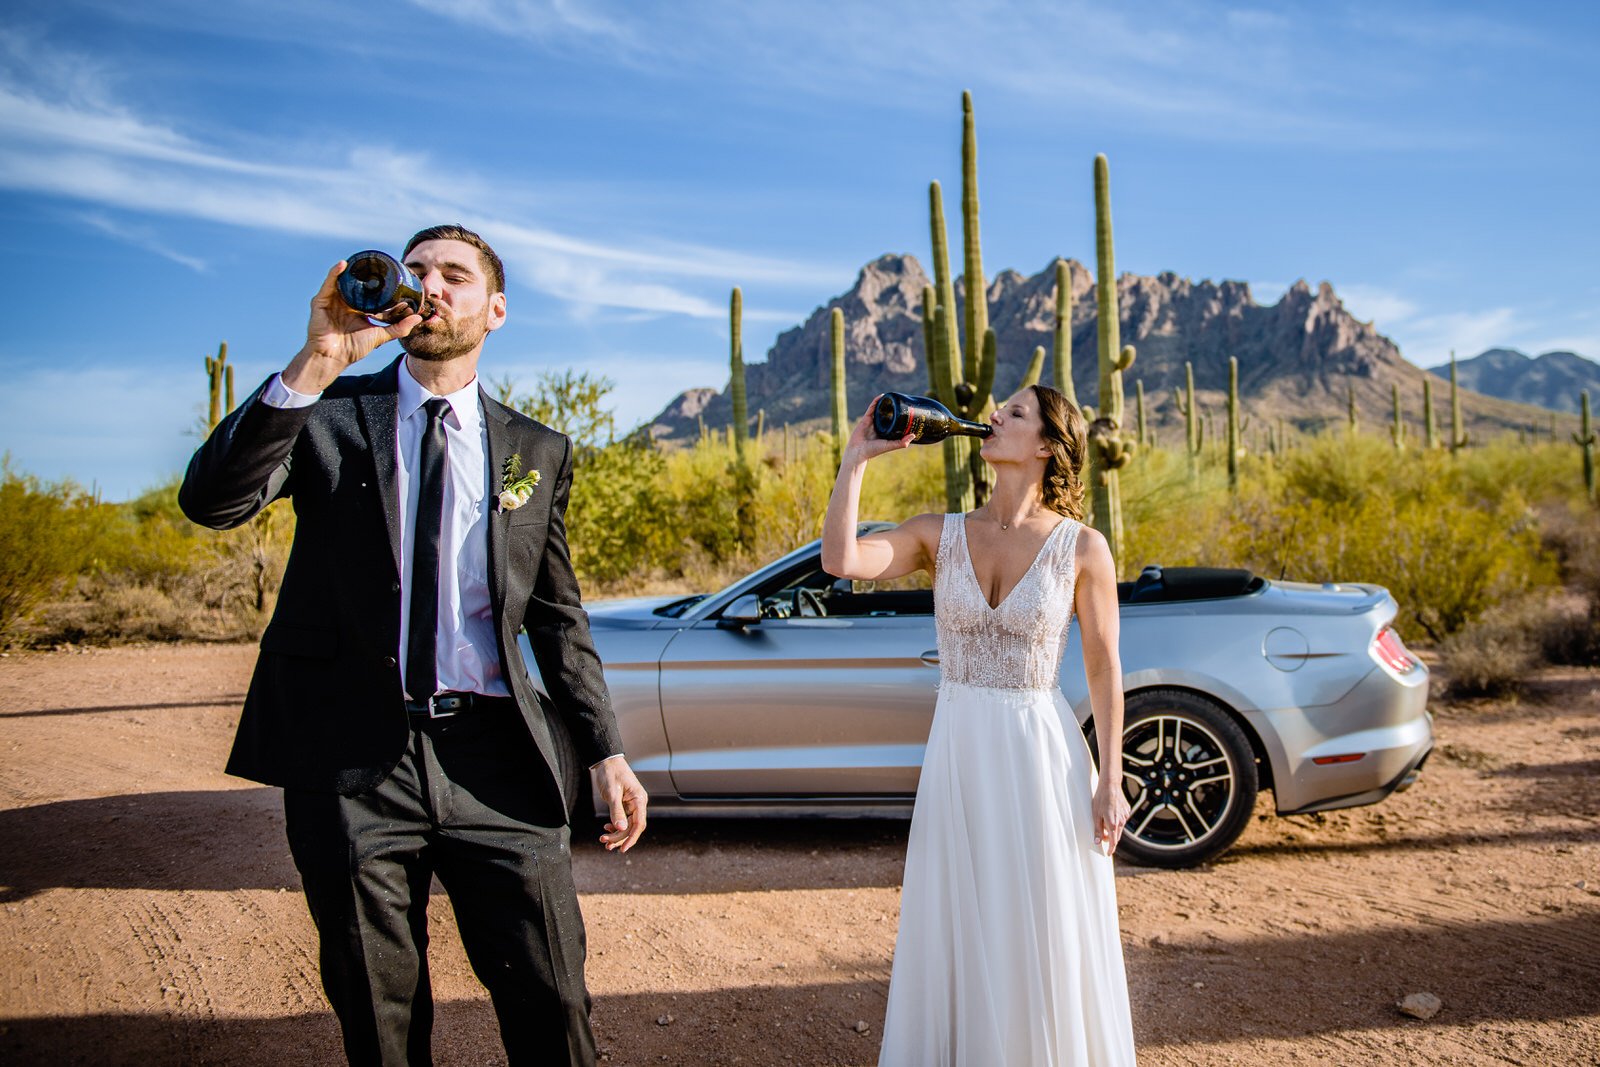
[178,226,646,1064]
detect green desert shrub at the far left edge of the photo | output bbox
[0,461,101,635]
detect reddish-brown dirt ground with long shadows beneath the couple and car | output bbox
[0,646,1600,1067]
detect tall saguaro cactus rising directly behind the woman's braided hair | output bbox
[1085,154,1134,571]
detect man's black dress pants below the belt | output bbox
[283,701,595,1067]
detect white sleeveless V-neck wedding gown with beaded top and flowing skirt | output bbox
[878,515,1134,1067]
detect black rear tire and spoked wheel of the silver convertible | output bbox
[1091,689,1261,869]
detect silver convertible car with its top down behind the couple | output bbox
[523,523,1434,867]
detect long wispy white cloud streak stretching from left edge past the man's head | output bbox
[0,30,843,322]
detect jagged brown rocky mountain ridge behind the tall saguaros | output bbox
[651,254,1574,442]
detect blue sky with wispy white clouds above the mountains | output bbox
[0,0,1600,499]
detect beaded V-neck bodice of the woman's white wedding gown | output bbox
[933,514,1083,689]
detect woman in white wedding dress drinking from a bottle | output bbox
[822,386,1134,1067]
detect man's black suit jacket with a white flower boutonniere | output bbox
[178,360,622,798]
